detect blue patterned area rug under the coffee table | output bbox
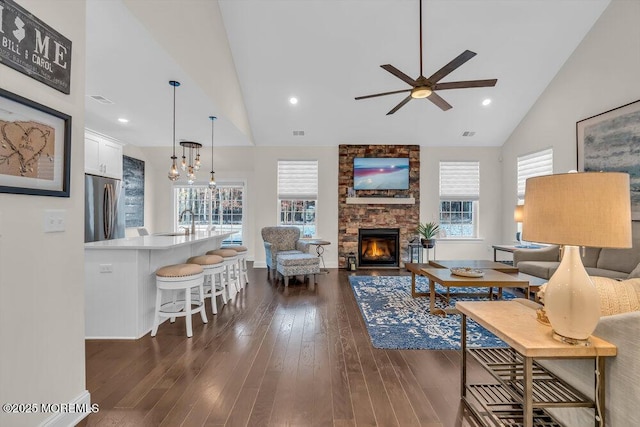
[349,276,515,350]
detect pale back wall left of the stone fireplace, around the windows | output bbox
[138,147,338,268]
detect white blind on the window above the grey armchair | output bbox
[278,160,318,200]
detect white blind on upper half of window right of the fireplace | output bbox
[440,162,480,200]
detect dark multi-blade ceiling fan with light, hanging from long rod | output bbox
[356,0,498,115]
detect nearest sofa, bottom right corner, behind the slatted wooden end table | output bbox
[529,277,640,427]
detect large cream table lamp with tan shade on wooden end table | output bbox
[522,172,631,345]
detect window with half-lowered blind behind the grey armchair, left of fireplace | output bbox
[278,160,318,237]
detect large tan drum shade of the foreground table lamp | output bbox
[522,172,631,248]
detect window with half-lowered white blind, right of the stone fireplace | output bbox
[440,162,480,238]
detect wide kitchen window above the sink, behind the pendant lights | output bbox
[174,183,244,243]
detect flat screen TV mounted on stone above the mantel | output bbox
[353,157,409,190]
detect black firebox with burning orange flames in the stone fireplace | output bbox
[358,228,400,267]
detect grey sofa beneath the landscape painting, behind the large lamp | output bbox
[513,222,640,279]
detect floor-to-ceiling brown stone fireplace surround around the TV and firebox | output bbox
[338,145,420,268]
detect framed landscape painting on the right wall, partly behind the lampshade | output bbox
[576,100,640,221]
